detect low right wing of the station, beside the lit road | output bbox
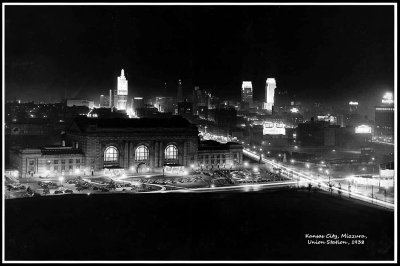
[197,140,243,169]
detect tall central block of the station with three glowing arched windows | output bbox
[66,117,199,172]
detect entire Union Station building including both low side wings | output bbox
[12,116,242,177]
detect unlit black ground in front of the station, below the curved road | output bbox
[5,190,394,260]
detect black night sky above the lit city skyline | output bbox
[5,6,394,110]
